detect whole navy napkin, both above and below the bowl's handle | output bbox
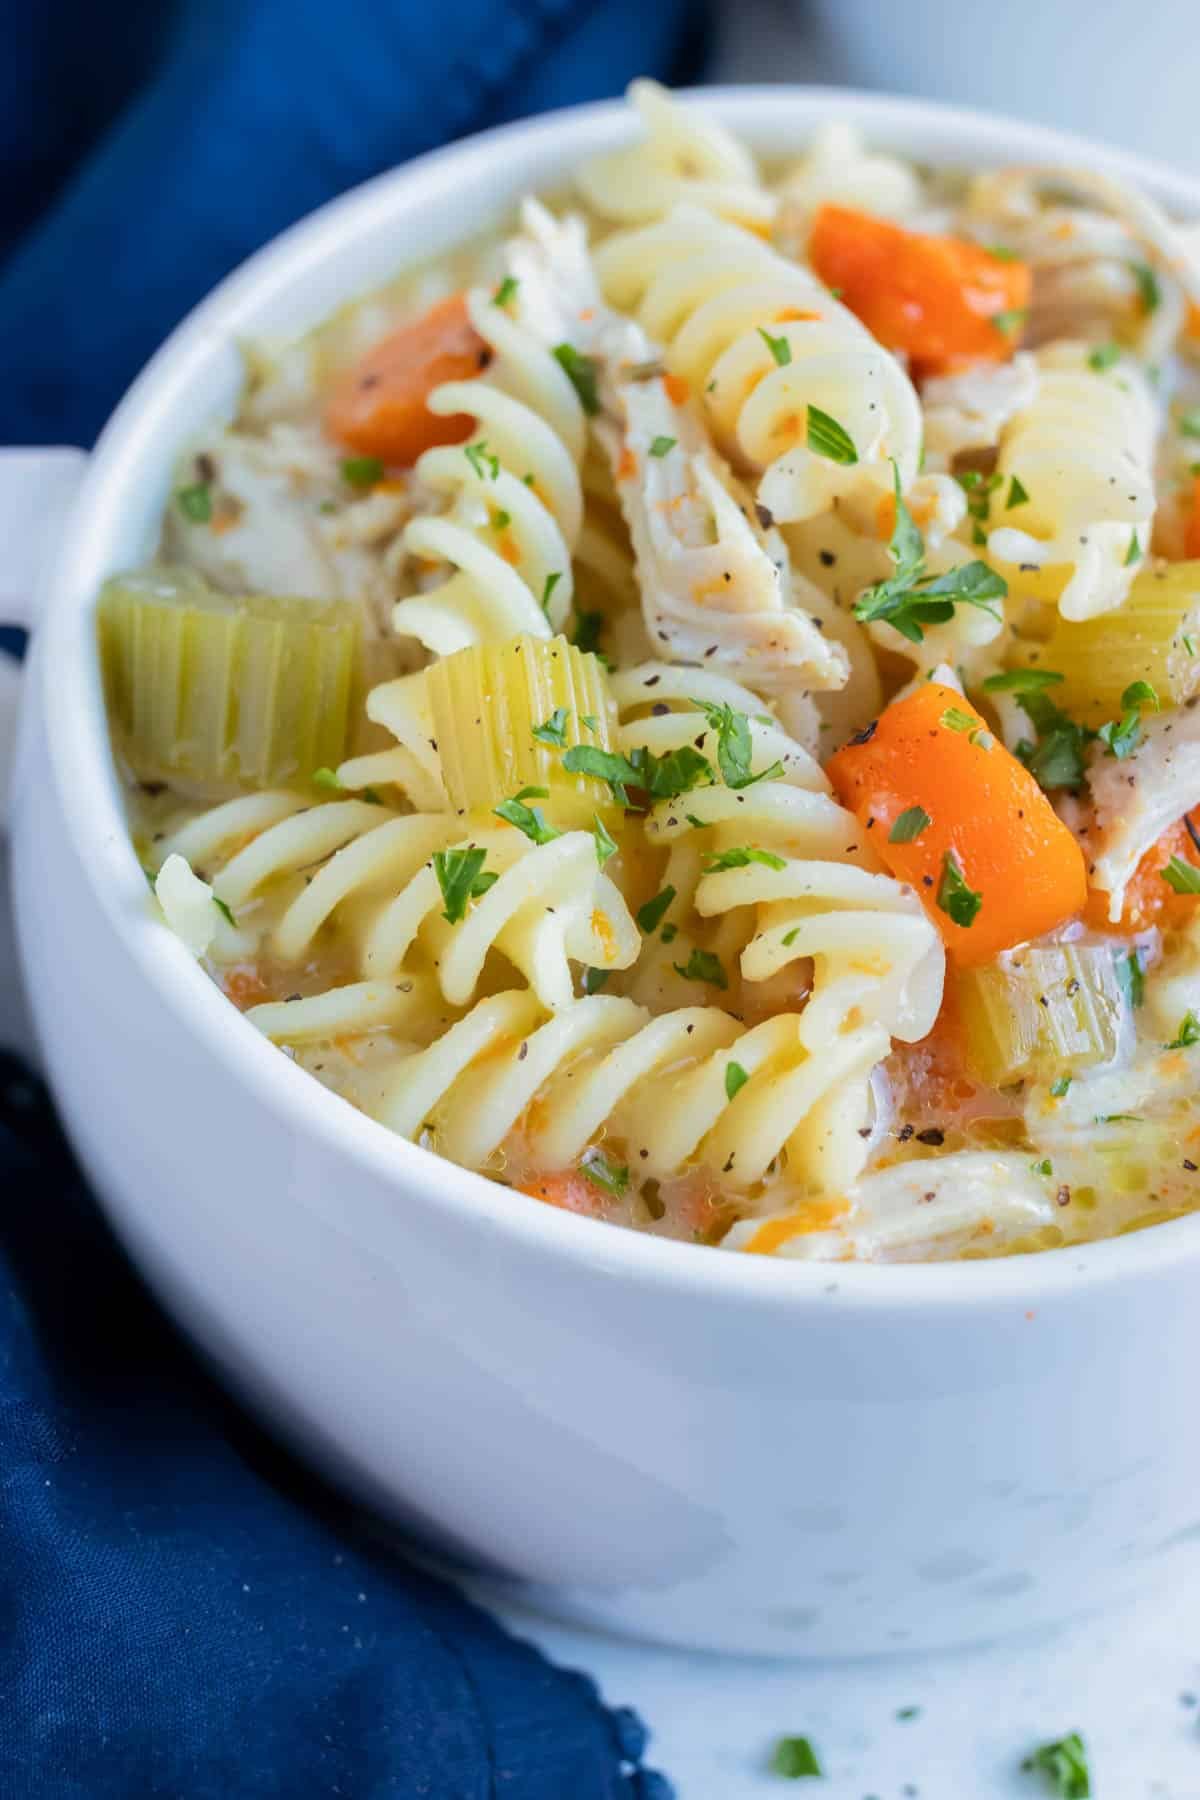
[0,0,703,1800]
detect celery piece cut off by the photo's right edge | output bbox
[1027,562,1200,727]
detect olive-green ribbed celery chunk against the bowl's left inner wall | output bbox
[99,567,358,788]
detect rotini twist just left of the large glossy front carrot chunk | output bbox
[646,781,945,1051]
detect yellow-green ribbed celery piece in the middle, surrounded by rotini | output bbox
[426,637,613,826]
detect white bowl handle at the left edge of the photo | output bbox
[0,448,88,835]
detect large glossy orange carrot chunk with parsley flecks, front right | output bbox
[829,682,1087,968]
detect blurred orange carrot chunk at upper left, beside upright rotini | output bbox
[326,293,489,468]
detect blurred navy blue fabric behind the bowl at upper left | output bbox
[0,0,705,446]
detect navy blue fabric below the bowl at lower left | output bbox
[0,1053,669,1800]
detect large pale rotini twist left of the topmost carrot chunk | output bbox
[596,207,921,524]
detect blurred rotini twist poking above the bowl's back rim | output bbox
[576,79,775,225]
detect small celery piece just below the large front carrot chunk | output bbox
[959,943,1124,1087]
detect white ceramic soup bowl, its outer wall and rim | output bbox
[9,88,1200,1654]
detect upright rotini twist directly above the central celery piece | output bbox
[392,288,587,655]
